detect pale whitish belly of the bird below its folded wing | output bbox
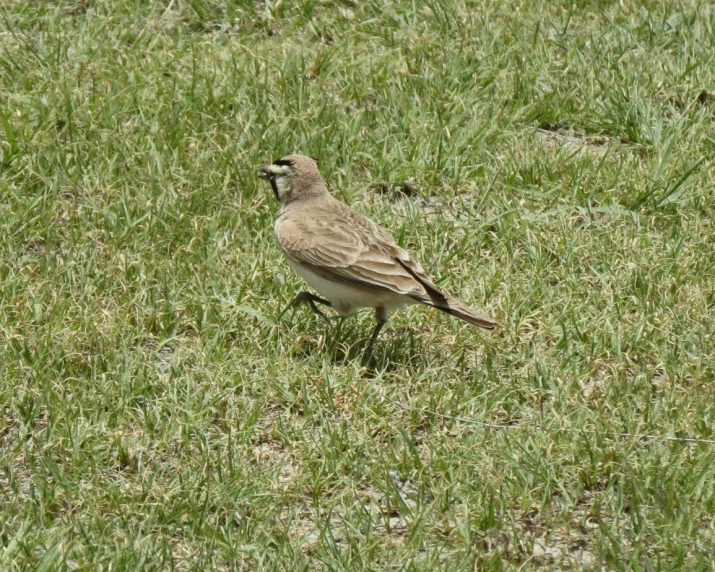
[286,256,416,314]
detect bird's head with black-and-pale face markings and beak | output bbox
[258,155,327,203]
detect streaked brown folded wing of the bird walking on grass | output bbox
[275,203,429,297]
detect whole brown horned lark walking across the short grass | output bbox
[259,155,498,346]
